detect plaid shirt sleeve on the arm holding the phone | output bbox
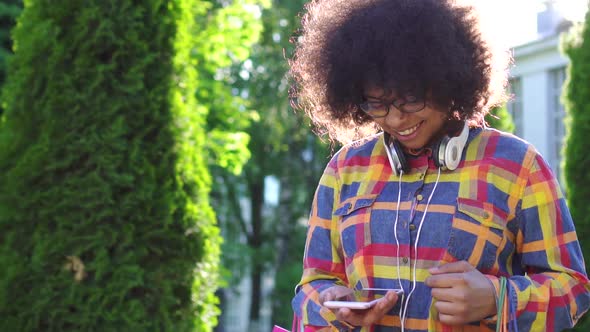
[292,155,348,331]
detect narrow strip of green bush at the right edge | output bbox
[562,13,590,331]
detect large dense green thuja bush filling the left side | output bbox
[0,0,220,331]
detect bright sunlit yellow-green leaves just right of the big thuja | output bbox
[200,0,269,174]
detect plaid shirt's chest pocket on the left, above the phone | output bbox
[334,194,377,258]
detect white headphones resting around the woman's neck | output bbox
[383,122,469,175]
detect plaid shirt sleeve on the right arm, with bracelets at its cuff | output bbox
[507,152,590,331]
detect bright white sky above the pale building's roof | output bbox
[475,0,588,46]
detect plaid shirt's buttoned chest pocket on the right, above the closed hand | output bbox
[447,197,507,272]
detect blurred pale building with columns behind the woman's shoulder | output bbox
[507,1,572,187]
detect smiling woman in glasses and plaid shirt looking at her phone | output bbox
[291,0,590,332]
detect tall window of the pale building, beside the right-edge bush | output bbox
[548,67,565,180]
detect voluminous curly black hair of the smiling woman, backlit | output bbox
[290,0,508,143]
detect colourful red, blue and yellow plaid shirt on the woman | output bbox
[293,128,590,332]
